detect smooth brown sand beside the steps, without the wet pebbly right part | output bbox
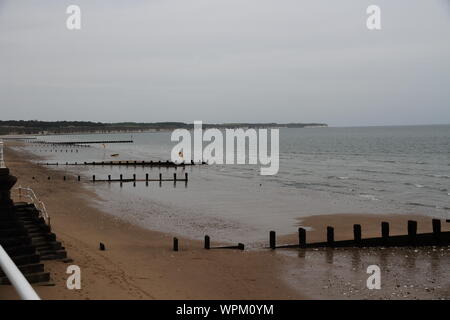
[0,143,306,299]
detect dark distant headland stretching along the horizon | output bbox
[0,120,328,135]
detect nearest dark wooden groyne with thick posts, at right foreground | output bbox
[269,219,450,249]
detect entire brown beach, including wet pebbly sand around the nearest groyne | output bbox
[0,142,450,299]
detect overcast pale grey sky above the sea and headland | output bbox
[0,0,450,126]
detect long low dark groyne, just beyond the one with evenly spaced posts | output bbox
[40,160,207,168]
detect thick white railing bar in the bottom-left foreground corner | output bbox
[0,245,41,300]
